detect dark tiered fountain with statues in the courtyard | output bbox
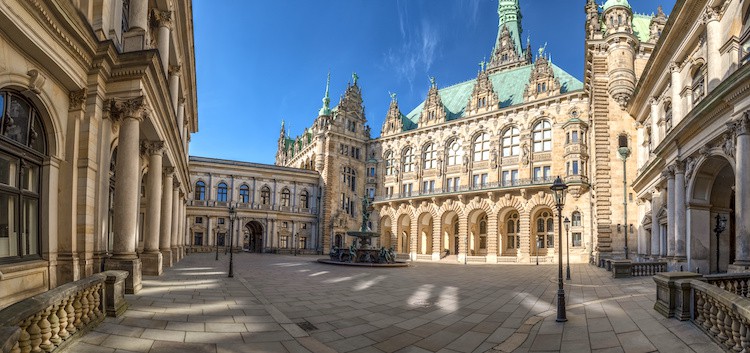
[318,197,408,267]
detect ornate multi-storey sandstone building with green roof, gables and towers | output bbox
[276,0,667,263]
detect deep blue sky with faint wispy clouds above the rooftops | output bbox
[190,0,675,164]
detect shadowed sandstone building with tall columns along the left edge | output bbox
[0,0,197,307]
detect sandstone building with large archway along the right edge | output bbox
[627,0,750,274]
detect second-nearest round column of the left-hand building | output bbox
[141,141,164,276]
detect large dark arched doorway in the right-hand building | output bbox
[686,156,736,273]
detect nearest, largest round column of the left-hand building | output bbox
[105,95,147,294]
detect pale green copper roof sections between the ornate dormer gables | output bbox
[403,64,583,131]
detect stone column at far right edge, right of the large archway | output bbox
[729,115,750,266]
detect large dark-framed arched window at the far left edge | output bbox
[0,91,47,262]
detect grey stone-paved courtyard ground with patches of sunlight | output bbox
[67,253,722,353]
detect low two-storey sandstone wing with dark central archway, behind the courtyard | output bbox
[186,156,320,254]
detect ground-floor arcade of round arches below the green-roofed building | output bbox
[379,192,590,263]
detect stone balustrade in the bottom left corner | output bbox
[0,271,128,353]
